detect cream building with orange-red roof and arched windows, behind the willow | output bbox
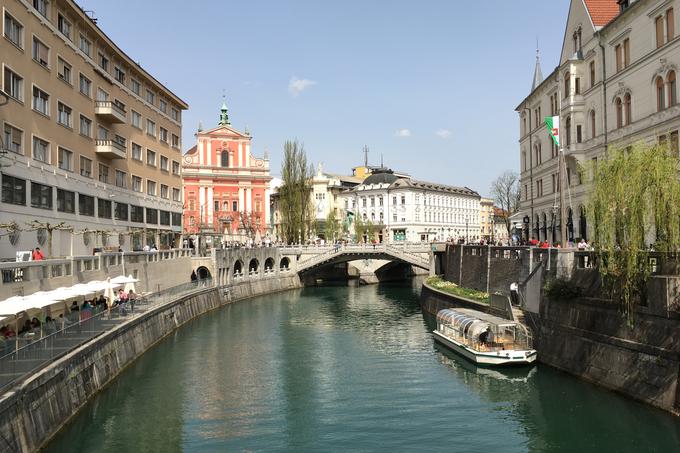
[517,0,680,244]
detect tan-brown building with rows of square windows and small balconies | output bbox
[0,0,188,258]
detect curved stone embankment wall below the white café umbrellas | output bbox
[0,275,301,452]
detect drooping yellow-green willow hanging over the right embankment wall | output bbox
[587,144,680,322]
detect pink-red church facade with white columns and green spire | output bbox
[182,104,272,246]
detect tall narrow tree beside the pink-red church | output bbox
[279,140,313,243]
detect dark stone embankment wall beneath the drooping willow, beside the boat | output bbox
[536,298,680,415]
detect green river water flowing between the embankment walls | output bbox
[46,281,680,453]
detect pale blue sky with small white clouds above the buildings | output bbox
[77,0,569,195]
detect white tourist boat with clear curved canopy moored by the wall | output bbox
[432,308,536,366]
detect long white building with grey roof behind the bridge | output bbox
[340,169,481,242]
